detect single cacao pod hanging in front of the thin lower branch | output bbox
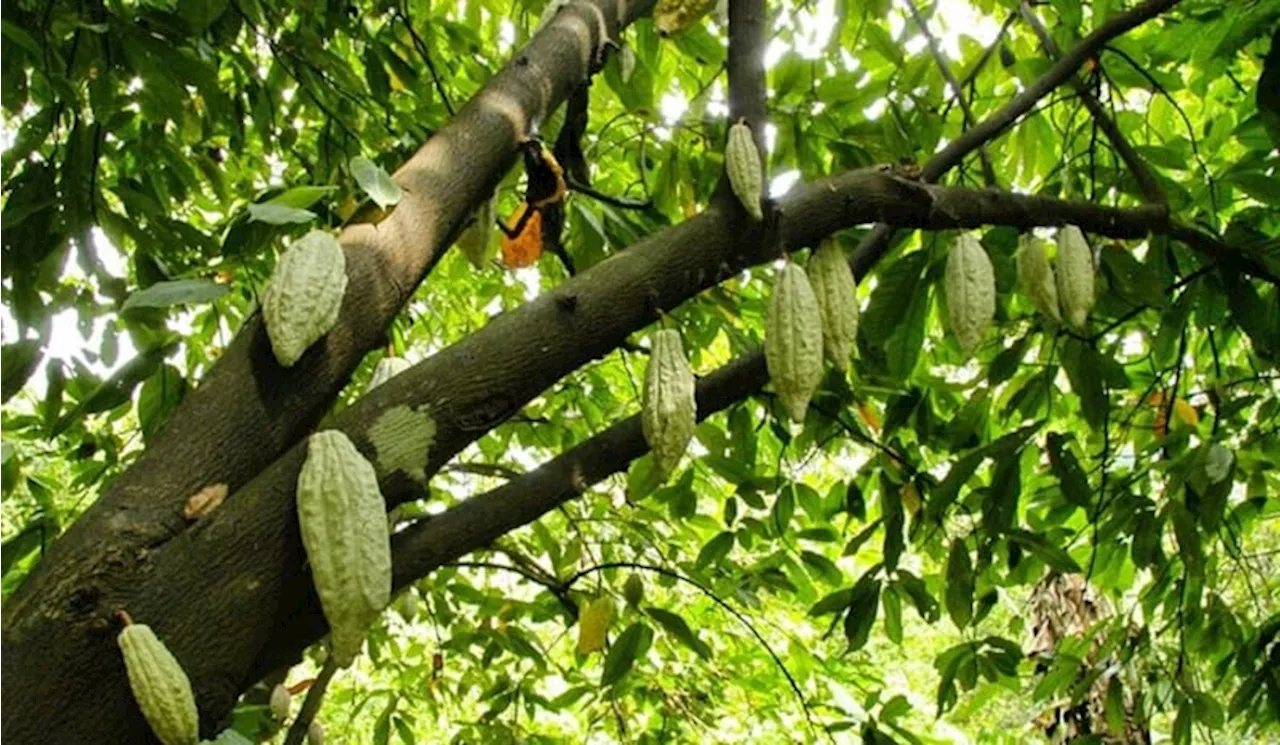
[640,329,698,480]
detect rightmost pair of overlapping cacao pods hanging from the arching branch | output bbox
[1018,225,1094,329]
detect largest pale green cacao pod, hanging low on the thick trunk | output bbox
[297,430,392,667]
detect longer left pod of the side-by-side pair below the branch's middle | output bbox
[764,262,822,422]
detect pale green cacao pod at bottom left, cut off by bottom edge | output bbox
[116,623,200,745]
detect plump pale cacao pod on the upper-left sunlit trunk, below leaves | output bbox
[262,230,347,367]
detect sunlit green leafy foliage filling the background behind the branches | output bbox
[0,0,1280,742]
